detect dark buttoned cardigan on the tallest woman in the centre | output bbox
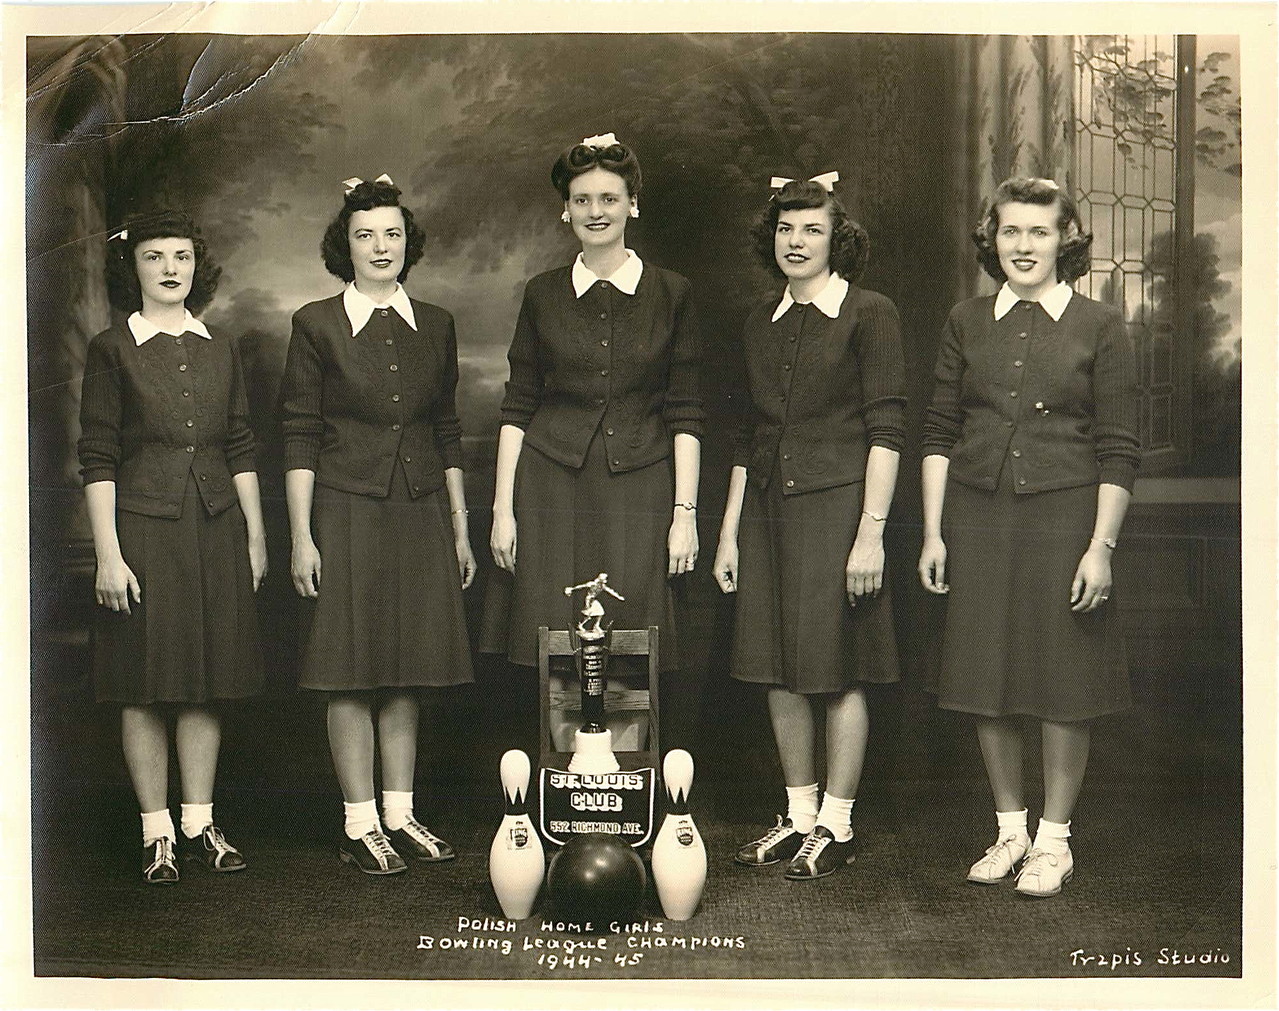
[501,264,705,472]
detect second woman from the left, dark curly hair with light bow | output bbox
[281,175,476,874]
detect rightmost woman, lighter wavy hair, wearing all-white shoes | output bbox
[920,177,1140,897]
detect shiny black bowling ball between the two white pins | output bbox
[546,832,648,930]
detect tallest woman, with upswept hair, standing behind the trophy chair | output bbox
[481,133,703,750]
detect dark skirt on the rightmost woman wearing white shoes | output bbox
[938,466,1132,722]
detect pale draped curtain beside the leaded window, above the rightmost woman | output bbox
[944,35,1074,299]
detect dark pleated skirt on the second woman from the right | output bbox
[732,474,899,695]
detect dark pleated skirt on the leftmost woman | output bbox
[93,475,263,705]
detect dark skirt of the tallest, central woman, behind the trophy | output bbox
[480,433,679,671]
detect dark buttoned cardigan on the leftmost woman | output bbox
[77,321,255,520]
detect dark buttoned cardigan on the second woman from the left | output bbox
[280,294,462,498]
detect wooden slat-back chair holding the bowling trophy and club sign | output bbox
[537,626,661,774]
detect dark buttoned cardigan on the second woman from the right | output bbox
[733,284,906,495]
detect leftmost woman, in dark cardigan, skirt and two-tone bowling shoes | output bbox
[78,211,266,884]
